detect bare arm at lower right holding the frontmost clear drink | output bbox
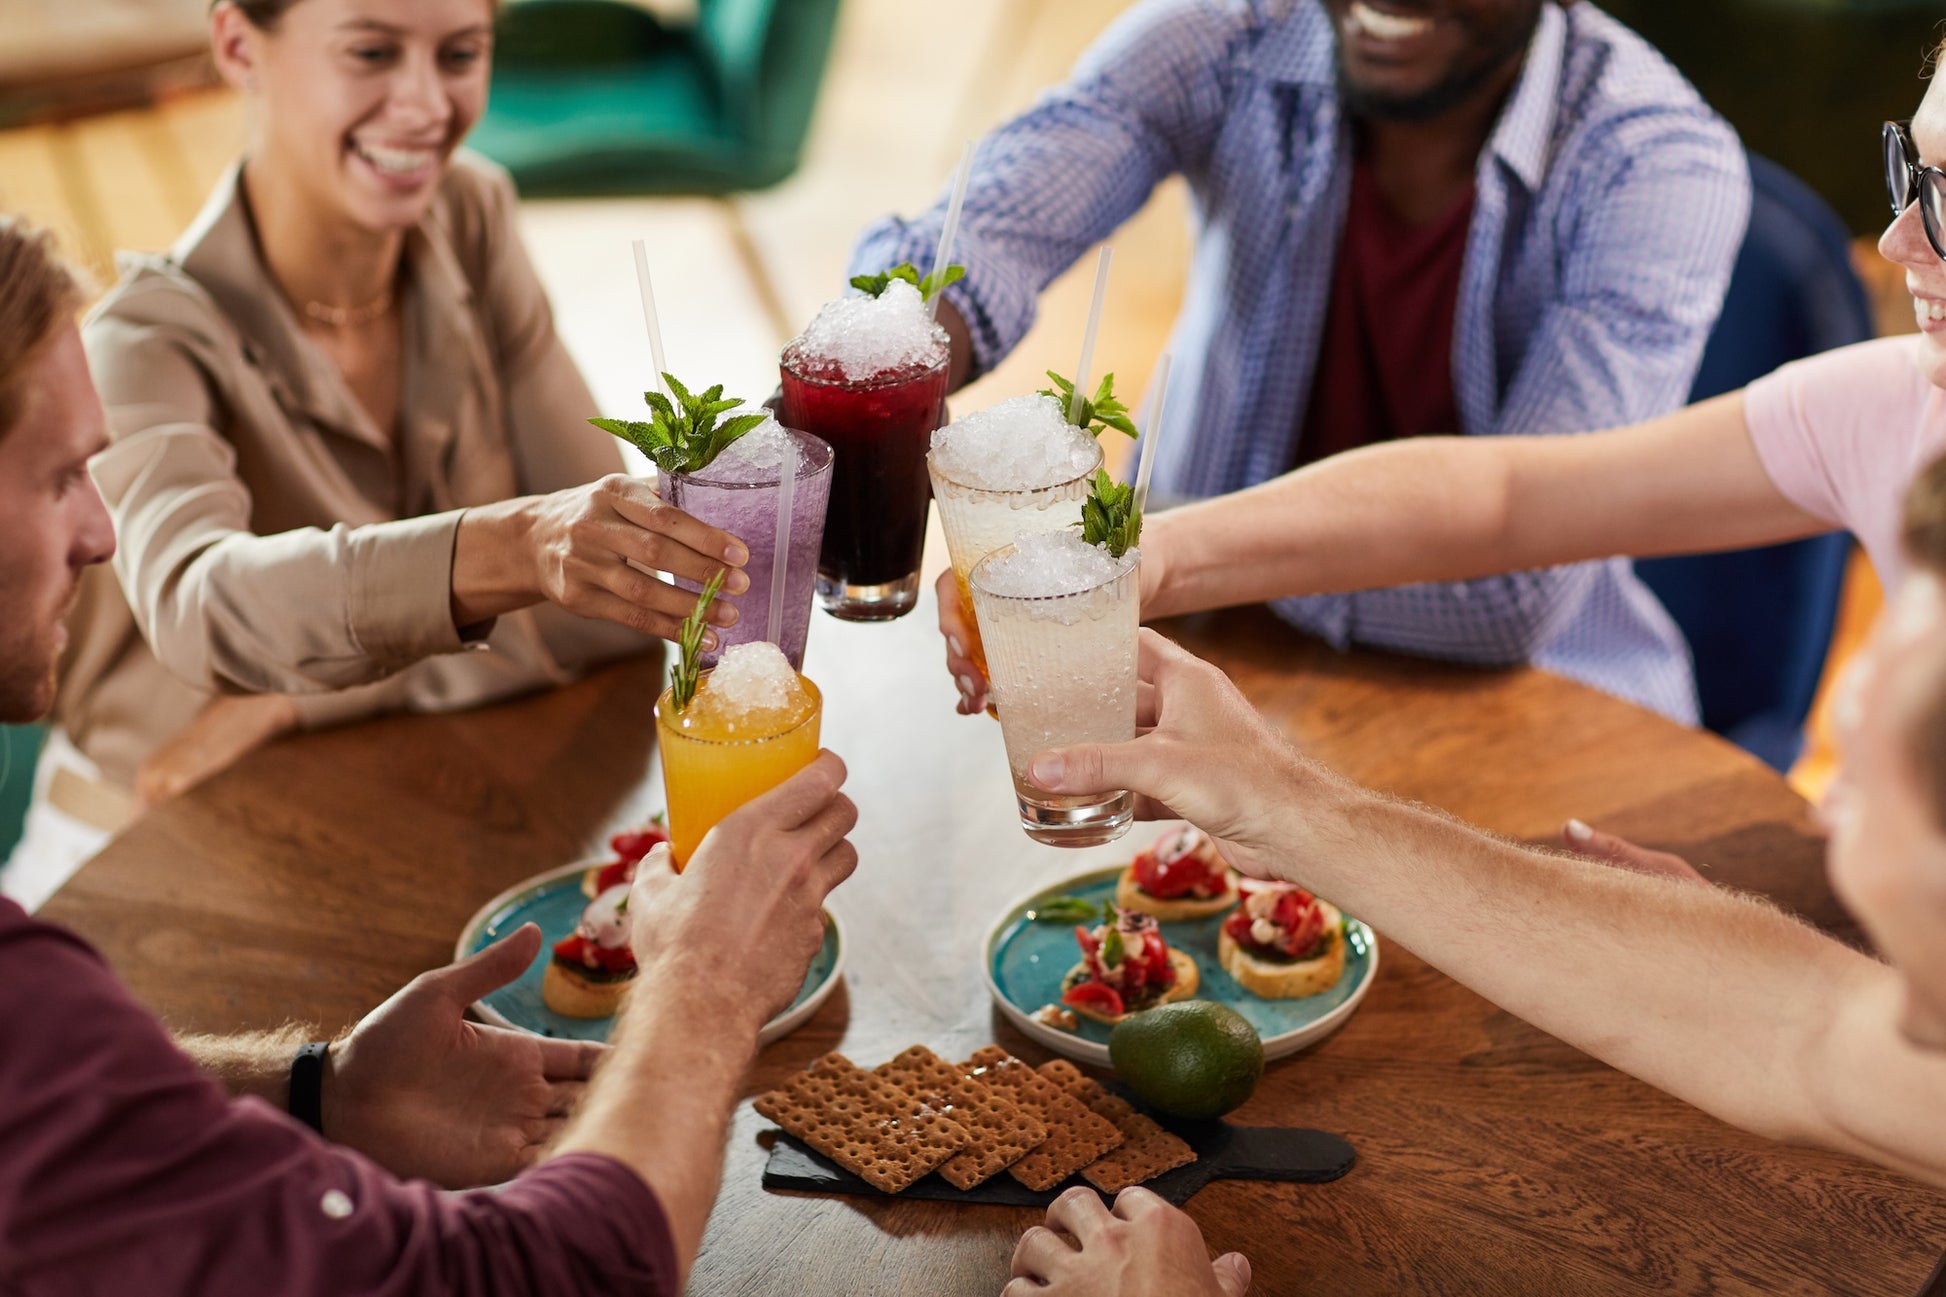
[1033,631,1946,1184]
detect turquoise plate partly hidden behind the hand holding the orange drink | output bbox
[465,857,845,1044]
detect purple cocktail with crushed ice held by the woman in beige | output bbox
[664,419,833,668]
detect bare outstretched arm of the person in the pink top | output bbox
[1142,393,1829,617]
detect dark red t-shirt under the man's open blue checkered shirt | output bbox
[1296,158,1473,465]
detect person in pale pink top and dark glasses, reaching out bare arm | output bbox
[948,55,1946,709]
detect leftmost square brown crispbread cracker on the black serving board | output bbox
[755,1054,967,1194]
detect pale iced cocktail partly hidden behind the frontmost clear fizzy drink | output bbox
[926,374,1133,676]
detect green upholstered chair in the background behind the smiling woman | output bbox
[471,0,839,195]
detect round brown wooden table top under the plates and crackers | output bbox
[45,606,1946,1297]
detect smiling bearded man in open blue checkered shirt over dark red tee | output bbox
[852,0,1749,723]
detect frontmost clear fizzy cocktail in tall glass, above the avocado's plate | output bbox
[971,529,1140,847]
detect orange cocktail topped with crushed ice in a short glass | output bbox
[656,641,823,869]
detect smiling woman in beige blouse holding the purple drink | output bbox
[8,0,747,894]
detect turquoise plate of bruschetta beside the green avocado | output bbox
[987,865,1378,1067]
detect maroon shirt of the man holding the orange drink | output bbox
[0,900,677,1297]
